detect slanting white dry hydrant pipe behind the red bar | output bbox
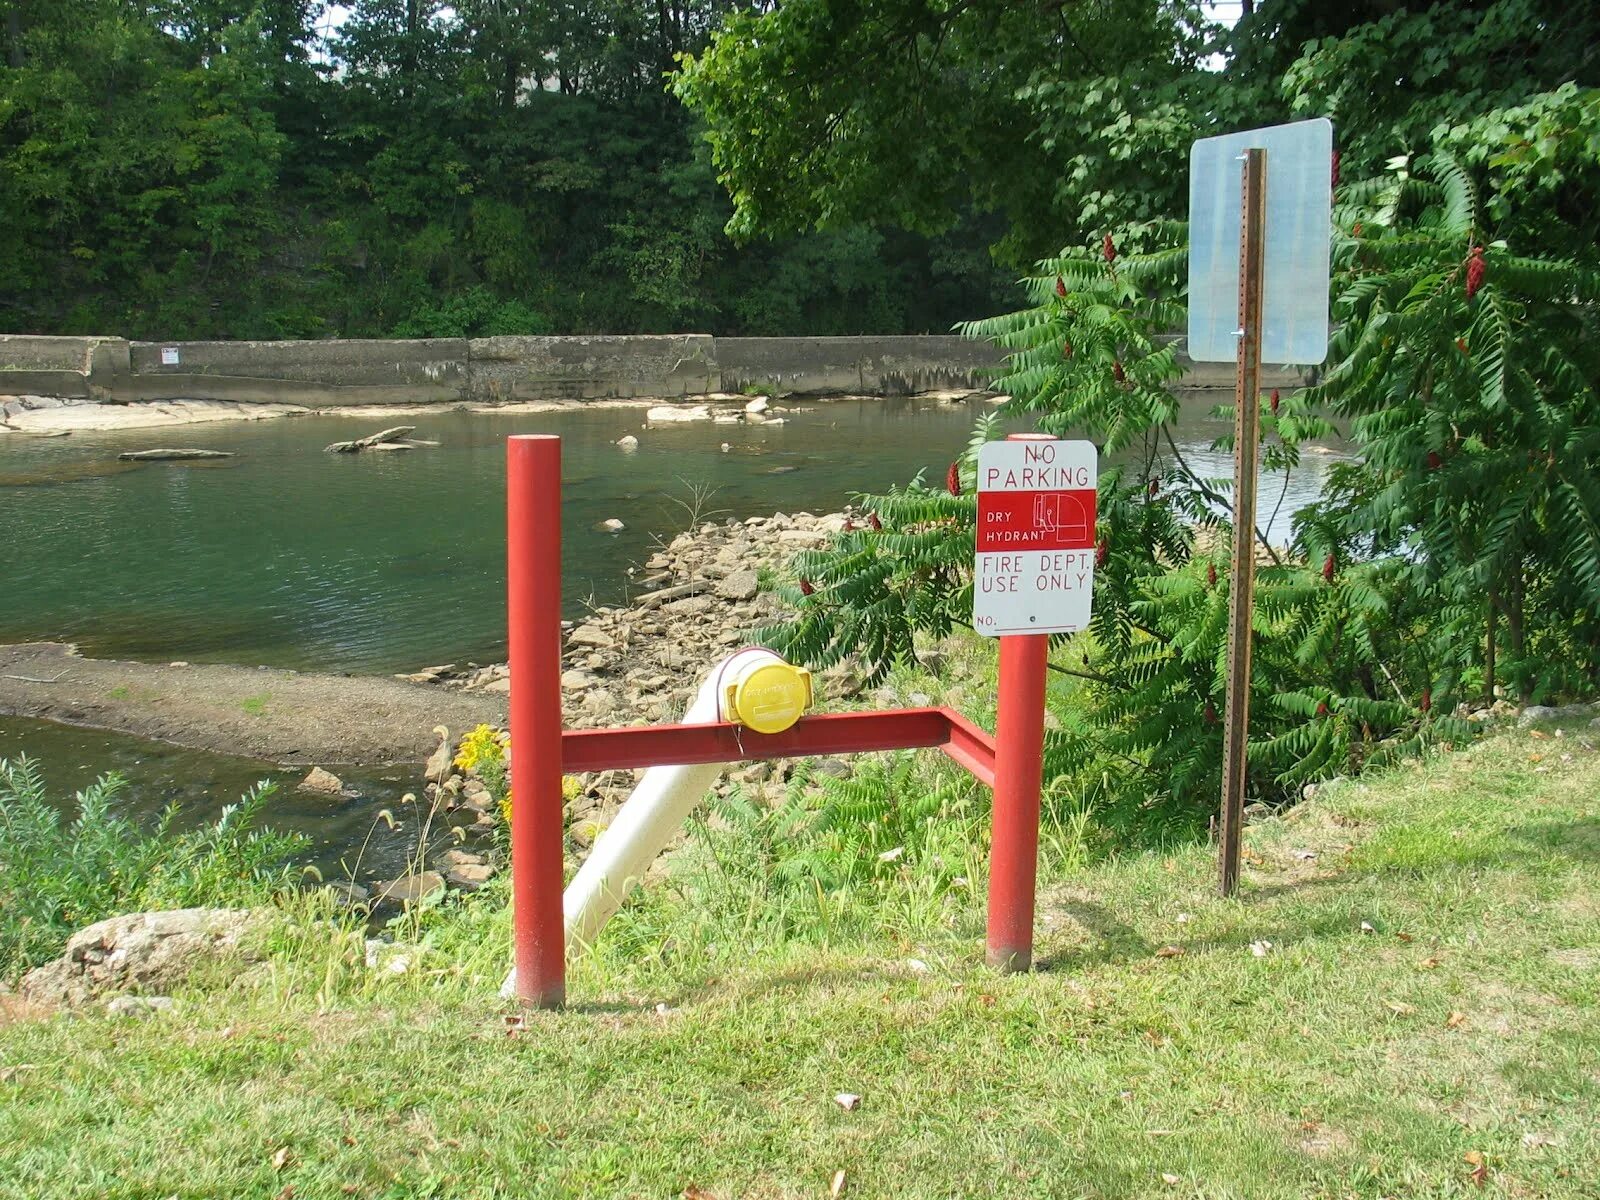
[501,646,782,998]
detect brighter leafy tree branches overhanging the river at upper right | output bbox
[675,0,1600,264]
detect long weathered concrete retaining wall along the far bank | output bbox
[0,333,1299,408]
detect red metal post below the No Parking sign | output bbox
[989,634,1050,971]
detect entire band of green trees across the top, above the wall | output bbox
[0,0,1600,338]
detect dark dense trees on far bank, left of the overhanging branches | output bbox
[0,0,1010,338]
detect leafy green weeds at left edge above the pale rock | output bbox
[0,758,304,981]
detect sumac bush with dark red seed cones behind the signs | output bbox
[765,129,1600,835]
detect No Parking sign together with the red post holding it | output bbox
[973,434,1099,971]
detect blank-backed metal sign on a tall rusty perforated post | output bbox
[1189,118,1333,896]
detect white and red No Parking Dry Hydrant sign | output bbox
[973,435,1099,637]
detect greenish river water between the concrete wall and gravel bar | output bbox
[0,395,1328,672]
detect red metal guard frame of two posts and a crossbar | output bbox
[506,435,1050,1008]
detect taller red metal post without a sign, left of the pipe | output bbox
[506,435,566,1008]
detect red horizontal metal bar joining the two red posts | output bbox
[562,709,995,786]
